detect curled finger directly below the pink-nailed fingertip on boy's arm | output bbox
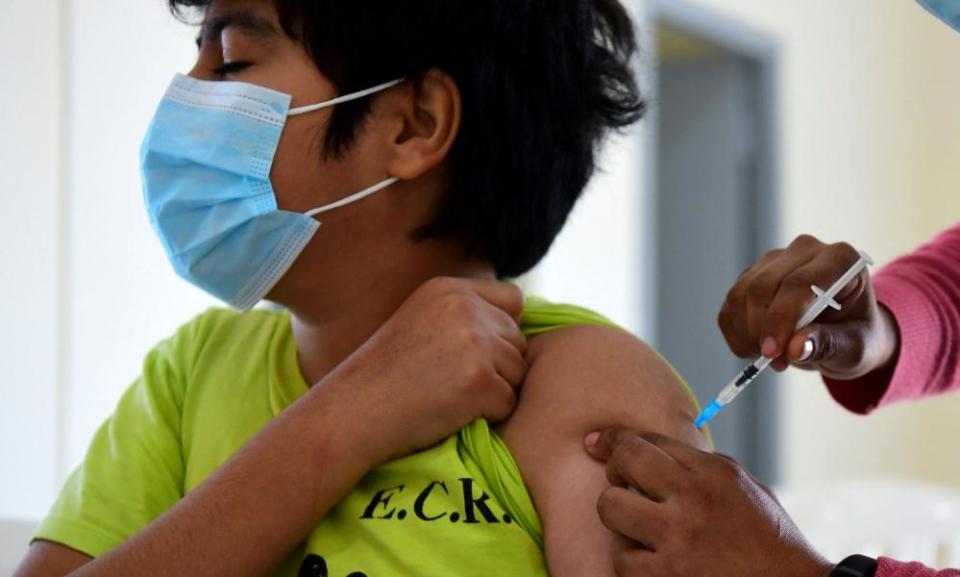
[607,435,688,503]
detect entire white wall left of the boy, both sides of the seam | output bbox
[0,0,213,519]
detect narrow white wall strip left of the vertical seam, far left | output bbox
[0,0,61,517]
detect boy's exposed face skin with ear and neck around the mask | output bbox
[190,0,456,300]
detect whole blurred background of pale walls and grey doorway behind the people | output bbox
[0,0,960,568]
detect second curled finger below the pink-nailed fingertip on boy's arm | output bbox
[597,487,667,551]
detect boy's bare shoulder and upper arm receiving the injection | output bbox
[500,326,707,577]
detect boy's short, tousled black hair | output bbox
[167,0,646,277]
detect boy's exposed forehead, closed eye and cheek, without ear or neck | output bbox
[190,0,398,220]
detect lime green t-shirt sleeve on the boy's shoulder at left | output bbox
[34,331,184,557]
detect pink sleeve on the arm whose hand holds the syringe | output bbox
[824,225,960,414]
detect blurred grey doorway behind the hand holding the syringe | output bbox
[649,0,780,483]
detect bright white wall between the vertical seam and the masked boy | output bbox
[60,0,214,473]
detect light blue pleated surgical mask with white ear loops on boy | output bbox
[140,75,401,311]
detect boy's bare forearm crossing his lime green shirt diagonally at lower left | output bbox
[72,380,366,577]
